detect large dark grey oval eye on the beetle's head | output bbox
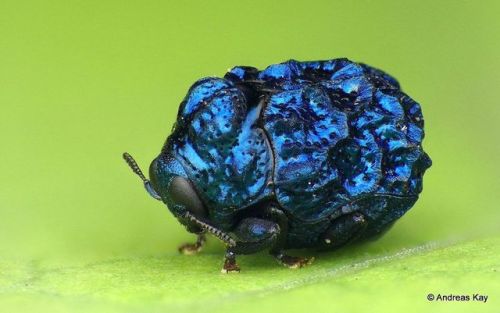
[168,176,206,217]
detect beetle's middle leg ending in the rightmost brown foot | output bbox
[264,206,314,268]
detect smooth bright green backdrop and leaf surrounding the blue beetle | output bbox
[0,0,500,312]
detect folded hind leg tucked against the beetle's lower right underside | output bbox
[321,212,367,248]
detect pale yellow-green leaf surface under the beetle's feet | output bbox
[0,237,500,312]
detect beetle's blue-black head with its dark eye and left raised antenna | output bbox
[123,153,206,233]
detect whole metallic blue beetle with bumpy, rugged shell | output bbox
[124,59,431,272]
